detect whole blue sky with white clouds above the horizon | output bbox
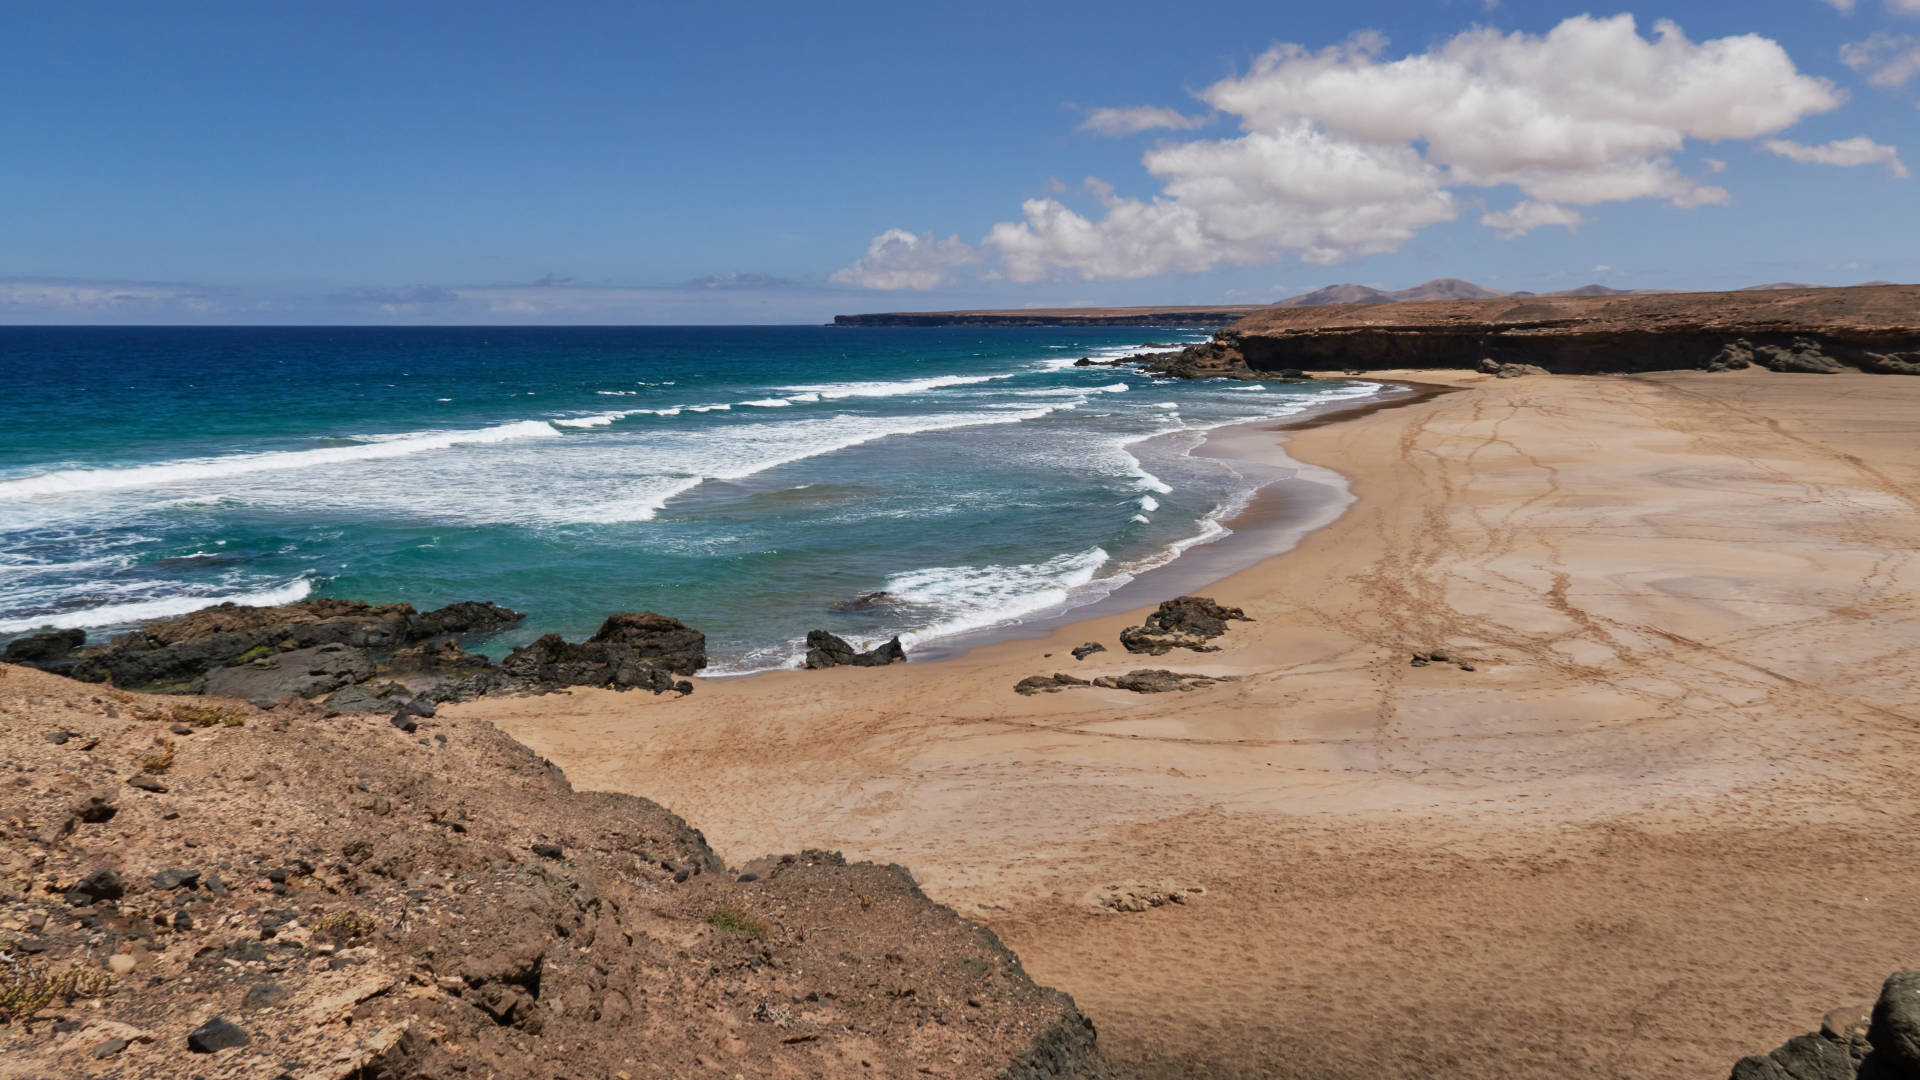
[0,0,1920,323]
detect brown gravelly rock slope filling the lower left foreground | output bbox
[0,665,1112,1080]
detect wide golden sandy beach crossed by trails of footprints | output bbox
[447,371,1920,1078]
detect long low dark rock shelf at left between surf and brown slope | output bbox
[59,600,520,694]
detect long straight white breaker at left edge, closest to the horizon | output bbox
[0,421,561,500]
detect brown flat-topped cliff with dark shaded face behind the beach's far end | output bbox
[1198,284,1920,375]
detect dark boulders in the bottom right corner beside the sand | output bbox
[1730,970,1920,1080]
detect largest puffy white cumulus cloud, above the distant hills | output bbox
[985,16,1843,281]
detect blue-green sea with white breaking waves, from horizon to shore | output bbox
[0,327,1373,673]
